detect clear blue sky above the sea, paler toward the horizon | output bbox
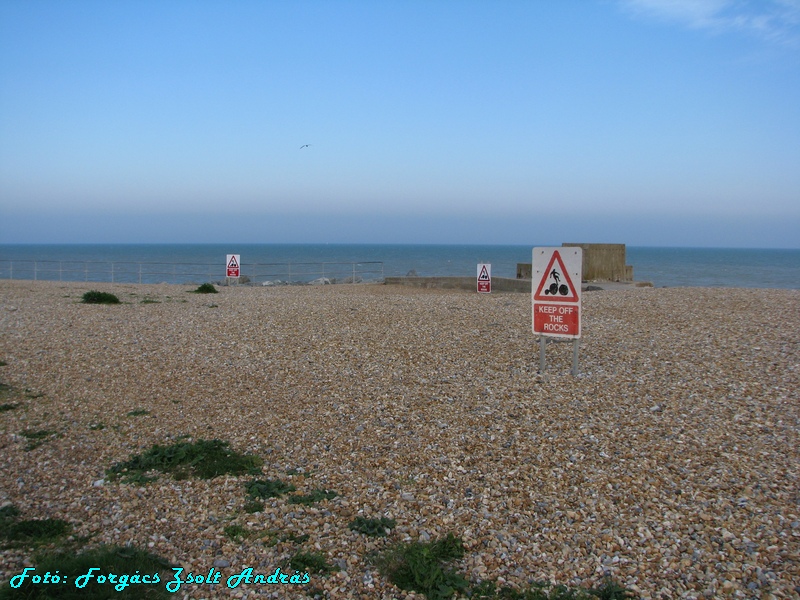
[0,0,800,248]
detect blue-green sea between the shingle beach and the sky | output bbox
[0,243,800,289]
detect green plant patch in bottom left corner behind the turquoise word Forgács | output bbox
[0,546,174,600]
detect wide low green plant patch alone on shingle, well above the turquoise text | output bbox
[106,440,263,482]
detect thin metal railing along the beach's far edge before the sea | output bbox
[0,259,384,285]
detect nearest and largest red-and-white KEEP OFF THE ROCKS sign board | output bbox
[531,246,583,338]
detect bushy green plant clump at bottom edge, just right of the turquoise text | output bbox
[377,533,468,600]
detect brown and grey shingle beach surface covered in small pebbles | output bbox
[0,281,800,598]
